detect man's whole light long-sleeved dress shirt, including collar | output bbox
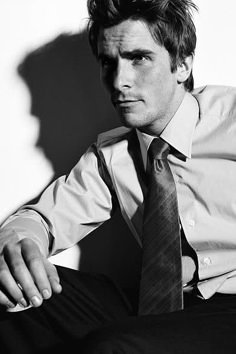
[0,86,236,299]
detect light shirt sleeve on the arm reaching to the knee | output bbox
[0,145,116,256]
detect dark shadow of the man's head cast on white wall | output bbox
[18,32,115,177]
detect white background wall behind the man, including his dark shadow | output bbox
[0,0,236,296]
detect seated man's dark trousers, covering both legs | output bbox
[0,267,236,354]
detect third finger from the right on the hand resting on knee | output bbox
[4,245,42,307]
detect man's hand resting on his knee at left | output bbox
[0,235,62,308]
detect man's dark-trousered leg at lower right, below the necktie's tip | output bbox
[83,296,236,354]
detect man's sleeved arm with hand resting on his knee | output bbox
[0,147,113,307]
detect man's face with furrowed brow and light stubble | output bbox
[98,20,185,135]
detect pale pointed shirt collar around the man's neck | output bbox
[137,92,199,166]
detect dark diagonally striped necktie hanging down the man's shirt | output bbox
[139,138,183,315]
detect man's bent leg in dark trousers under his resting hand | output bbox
[0,267,132,354]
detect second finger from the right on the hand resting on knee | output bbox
[21,240,52,299]
